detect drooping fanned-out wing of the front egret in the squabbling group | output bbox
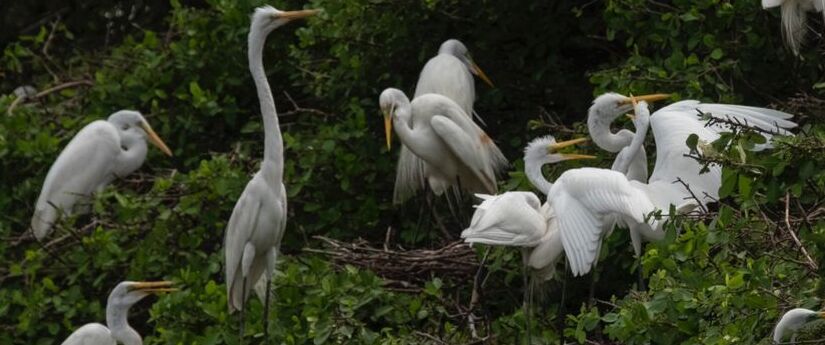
[547,168,658,276]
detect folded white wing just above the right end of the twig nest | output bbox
[461,192,547,247]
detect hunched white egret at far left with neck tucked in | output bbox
[31,110,172,241]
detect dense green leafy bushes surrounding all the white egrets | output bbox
[0,0,825,344]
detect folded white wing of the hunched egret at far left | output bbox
[31,121,120,240]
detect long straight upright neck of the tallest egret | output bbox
[248,28,284,188]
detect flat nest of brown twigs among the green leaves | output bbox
[304,236,478,292]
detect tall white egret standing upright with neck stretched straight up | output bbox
[224,6,318,337]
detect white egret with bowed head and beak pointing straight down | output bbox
[379,88,507,203]
